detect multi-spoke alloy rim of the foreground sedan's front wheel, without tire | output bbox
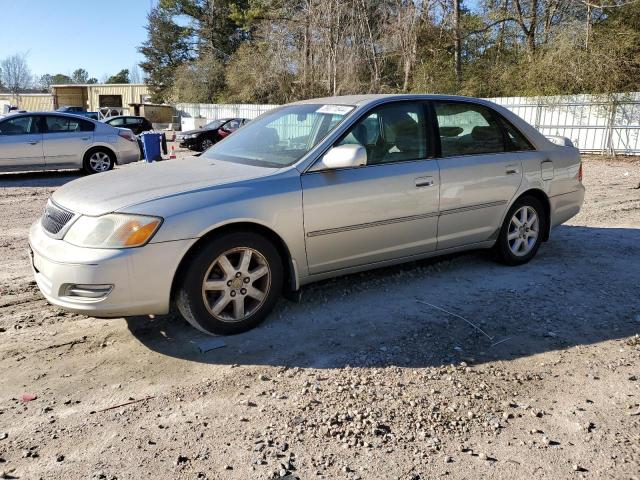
[202,247,271,323]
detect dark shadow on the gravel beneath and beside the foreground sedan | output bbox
[127,226,640,368]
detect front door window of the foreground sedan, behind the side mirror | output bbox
[338,103,427,165]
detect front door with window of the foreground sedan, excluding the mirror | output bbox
[302,102,439,274]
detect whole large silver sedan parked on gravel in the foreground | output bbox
[29,95,584,334]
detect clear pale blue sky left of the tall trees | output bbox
[0,0,155,80]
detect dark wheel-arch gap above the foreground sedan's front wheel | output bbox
[171,221,299,301]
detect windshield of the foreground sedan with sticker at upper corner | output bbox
[203,104,355,168]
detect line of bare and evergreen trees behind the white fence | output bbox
[139,0,640,103]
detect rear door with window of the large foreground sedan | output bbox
[432,101,522,250]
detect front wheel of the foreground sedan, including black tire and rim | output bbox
[175,232,283,335]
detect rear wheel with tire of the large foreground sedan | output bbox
[495,196,548,266]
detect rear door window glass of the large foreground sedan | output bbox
[434,102,505,157]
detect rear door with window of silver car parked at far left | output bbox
[43,115,95,168]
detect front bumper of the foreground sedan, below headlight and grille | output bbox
[29,221,192,317]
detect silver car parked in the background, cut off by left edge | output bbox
[0,112,140,173]
